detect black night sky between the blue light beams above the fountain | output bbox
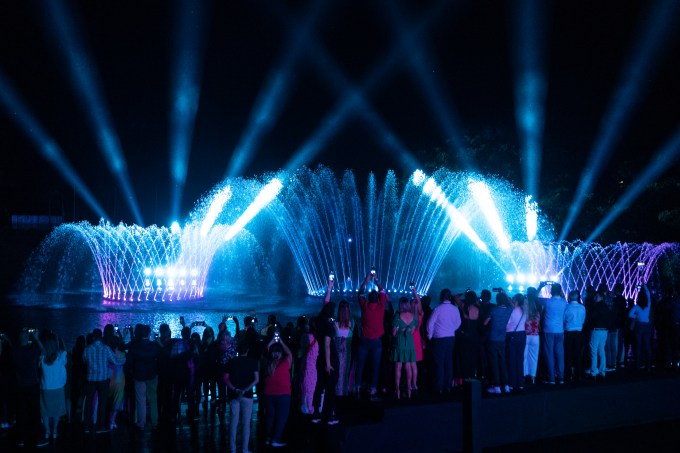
[0,0,680,240]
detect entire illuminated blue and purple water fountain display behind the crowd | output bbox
[17,166,678,302]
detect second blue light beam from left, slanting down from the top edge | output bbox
[45,0,144,225]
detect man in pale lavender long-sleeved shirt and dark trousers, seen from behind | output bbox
[427,288,460,393]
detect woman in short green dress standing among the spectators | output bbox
[392,297,418,399]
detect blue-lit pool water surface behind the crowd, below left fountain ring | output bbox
[0,294,332,347]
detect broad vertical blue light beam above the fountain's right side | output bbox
[512,0,547,198]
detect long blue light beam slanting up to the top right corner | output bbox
[559,0,680,241]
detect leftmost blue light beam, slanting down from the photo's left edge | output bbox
[0,72,109,220]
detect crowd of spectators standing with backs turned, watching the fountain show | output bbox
[0,271,680,452]
